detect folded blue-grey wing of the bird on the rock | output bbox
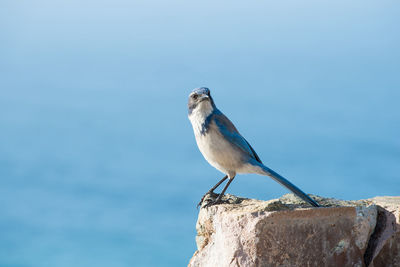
[213,111,262,163]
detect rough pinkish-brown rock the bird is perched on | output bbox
[189,194,400,267]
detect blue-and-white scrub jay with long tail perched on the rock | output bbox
[188,87,320,208]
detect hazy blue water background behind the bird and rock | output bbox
[0,0,400,267]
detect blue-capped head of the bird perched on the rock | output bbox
[188,87,215,115]
